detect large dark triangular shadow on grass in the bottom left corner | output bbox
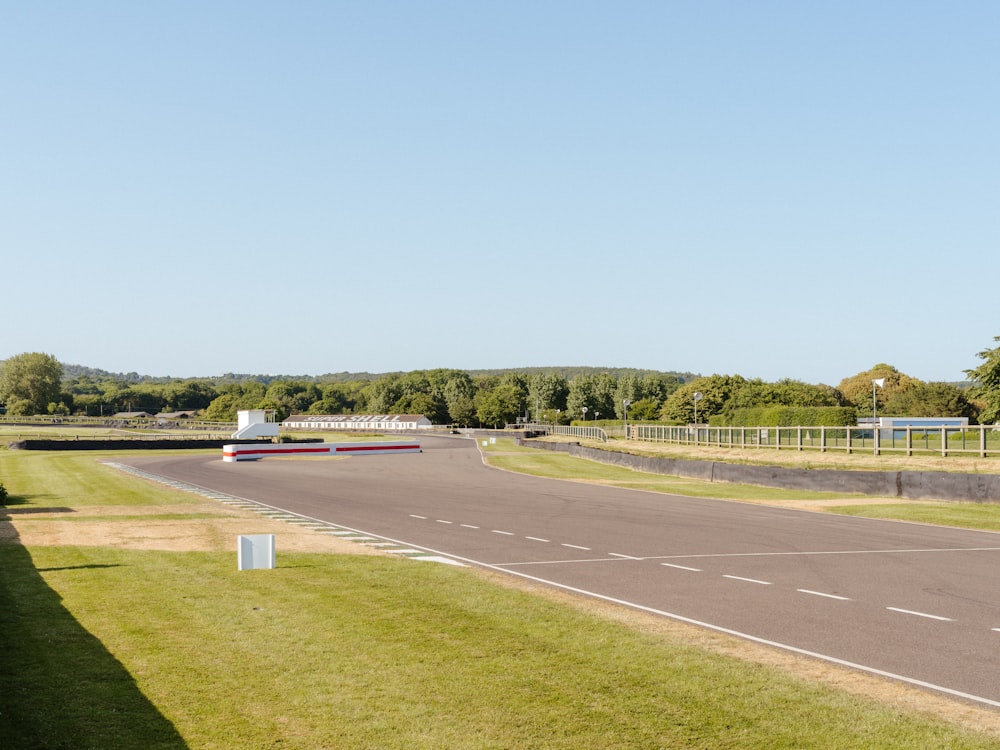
[0,521,187,750]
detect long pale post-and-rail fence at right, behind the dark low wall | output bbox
[629,425,1000,458]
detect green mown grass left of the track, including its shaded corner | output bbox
[0,444,1000,749]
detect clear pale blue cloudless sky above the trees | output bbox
[0,0,1000,385]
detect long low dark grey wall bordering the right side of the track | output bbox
[517,439,1000,503]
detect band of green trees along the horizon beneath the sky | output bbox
[0,337,1000,427]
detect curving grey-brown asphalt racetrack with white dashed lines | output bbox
[120,437,1000,707]
